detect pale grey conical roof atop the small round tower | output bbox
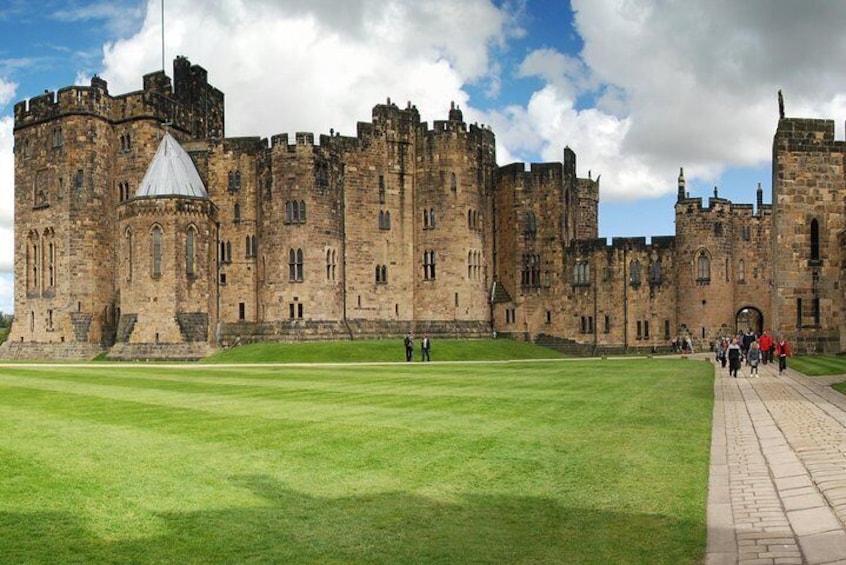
[135,132,209,198]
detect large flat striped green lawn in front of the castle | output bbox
[0,352,713,565]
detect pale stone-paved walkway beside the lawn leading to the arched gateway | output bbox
[705,354,846,565]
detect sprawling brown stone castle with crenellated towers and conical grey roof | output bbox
[0,57,846,359]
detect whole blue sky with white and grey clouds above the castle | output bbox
[0,0,846,312]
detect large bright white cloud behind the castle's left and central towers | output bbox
[97,0,513,141]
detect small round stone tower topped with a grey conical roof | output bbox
[109,133,217,359]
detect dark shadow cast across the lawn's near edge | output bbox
[0,476,705,565]
